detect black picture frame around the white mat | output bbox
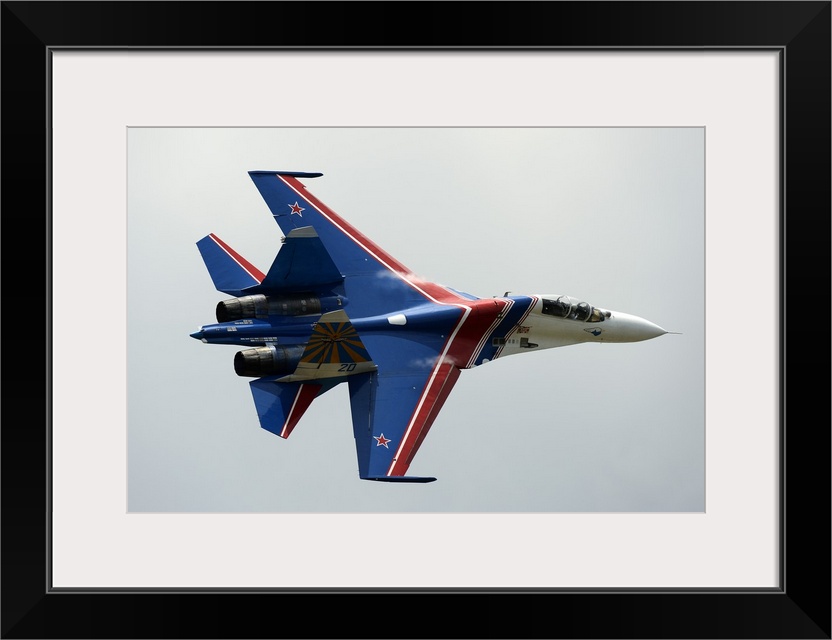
[0,1,832,638]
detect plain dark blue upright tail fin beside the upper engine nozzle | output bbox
[246,227,344,294]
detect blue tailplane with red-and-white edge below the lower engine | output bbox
[249,376,339,438]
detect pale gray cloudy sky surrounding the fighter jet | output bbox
[127,128,705,513]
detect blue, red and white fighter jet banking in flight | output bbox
[191,171,667,482]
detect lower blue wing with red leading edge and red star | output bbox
[349,362,460,482]
